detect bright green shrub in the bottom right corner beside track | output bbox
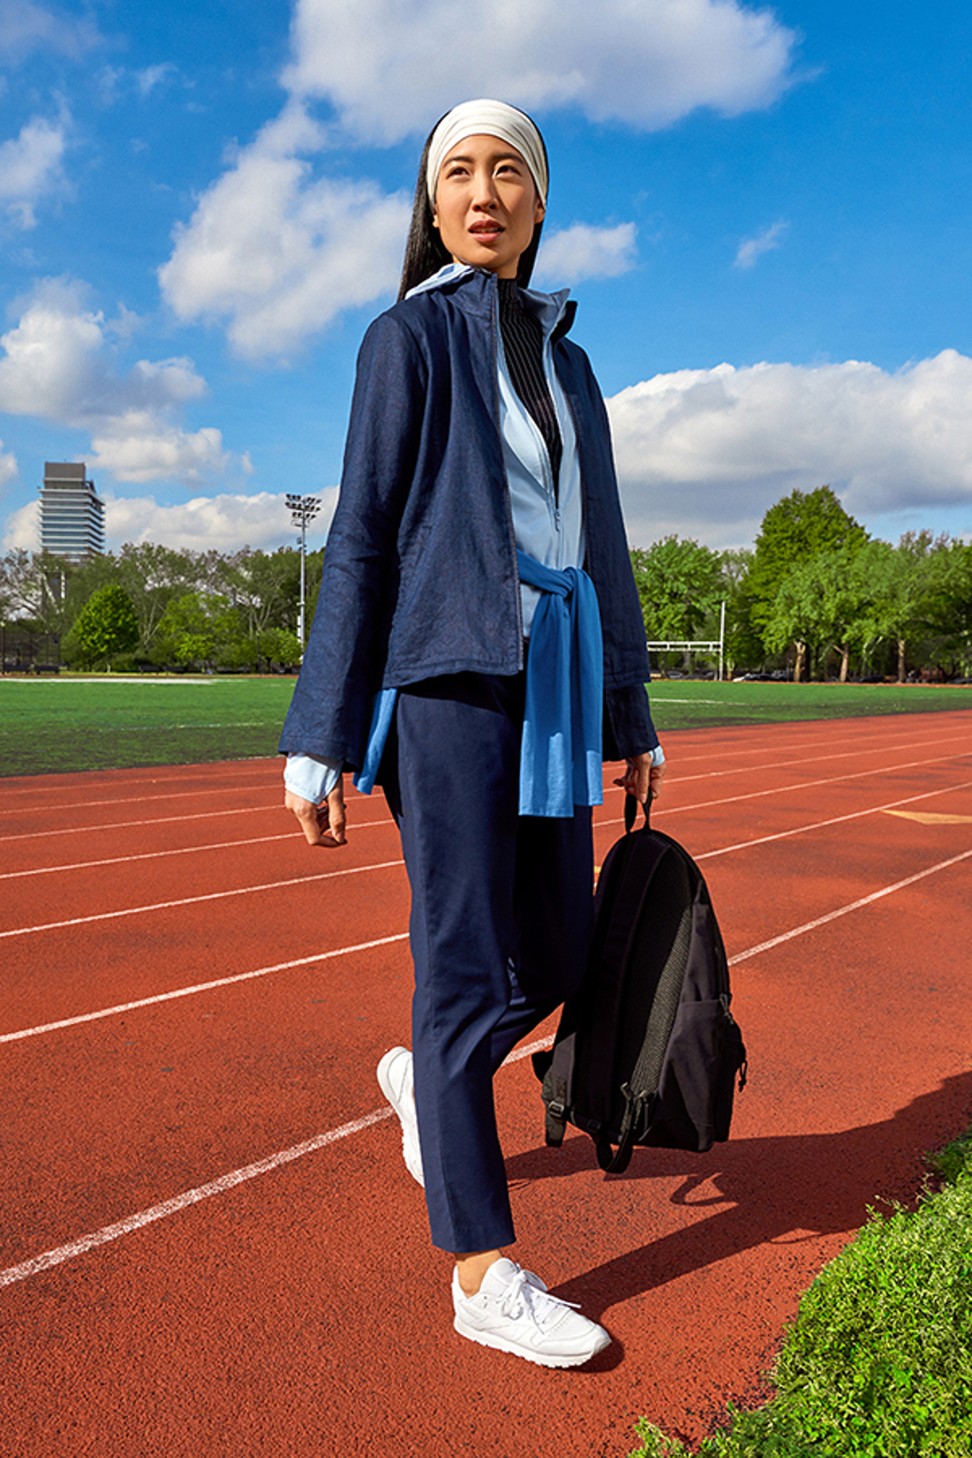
[631,1134,972,1458]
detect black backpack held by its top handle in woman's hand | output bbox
[533,796,746,1174]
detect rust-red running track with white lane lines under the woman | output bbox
[0,710,972,1458]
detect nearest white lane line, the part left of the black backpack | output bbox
[0,1038,549,1287]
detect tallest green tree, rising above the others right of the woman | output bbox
[745,486,867,679]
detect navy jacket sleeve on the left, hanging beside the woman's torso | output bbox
[280,313,427,770]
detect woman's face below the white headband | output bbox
[433,136,544,278]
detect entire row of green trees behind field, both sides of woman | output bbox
[0,486,972,681]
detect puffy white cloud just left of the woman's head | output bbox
[159,108,409,359]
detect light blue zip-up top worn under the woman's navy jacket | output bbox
[284,262,658,805]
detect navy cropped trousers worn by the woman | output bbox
[382,674,593,1252]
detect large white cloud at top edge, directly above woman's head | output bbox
[284,0,796,143]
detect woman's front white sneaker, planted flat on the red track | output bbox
[452,1255,611,1366]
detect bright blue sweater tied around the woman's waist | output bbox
[354,548,603,818]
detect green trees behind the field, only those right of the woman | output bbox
[631,486,972,682]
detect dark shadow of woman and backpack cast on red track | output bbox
[507,1073,972,1319]
